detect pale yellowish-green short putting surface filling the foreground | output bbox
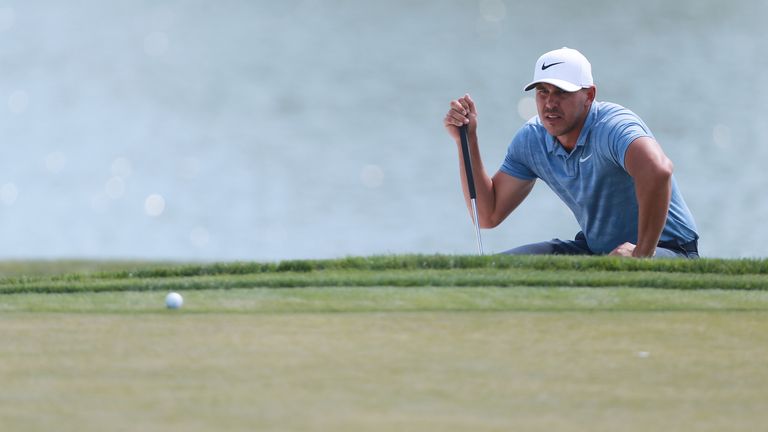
[0,308,768,432]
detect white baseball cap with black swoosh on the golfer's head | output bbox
[525,47,594,92]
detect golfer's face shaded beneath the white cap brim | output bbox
[536,83,595,137]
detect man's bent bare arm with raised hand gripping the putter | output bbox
[443,95,534,228]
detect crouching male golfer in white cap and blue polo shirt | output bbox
[444,48,699,258]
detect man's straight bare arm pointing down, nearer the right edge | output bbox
[611,137,674,257]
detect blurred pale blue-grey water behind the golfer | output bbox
[0,0,768,260]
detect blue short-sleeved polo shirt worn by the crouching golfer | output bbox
[501,101,699,254]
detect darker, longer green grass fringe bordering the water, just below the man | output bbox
[0,256,768,294]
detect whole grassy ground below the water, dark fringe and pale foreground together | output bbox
[0,256,768,432]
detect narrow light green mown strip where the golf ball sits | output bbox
[0,286,768,314]
